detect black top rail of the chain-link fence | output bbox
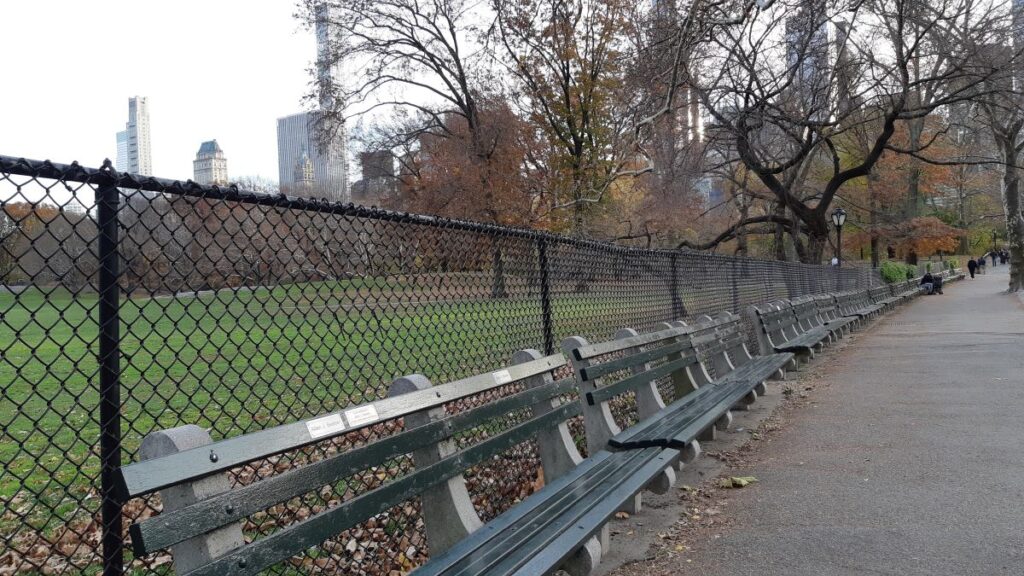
[0,155,839,266]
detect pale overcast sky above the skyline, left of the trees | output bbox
[0,0,316,180]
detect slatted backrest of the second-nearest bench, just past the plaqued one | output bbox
[562,322,712,454]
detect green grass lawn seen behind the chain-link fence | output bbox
[0,279,667,557]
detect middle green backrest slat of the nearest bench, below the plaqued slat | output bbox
[130,378,575,556]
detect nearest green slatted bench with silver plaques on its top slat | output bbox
[120,351,678,576]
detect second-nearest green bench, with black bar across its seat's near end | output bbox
[562,313,793,459]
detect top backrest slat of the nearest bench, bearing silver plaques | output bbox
[116,354,565,499]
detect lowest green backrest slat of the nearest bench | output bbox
[174,399,580,576]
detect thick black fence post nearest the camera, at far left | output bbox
[96,170,124,576]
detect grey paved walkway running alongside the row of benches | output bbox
[679,266,1024,576]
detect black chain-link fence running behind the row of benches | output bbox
[0,156,874,575]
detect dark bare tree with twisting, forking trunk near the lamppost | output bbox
[701,0,1007,262]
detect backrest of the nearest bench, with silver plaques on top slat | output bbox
[120,351,582,575]
